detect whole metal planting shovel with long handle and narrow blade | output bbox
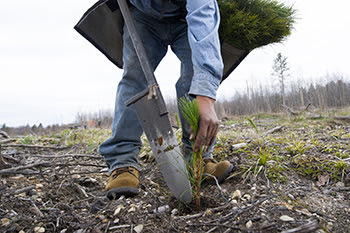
[118,0,192,203]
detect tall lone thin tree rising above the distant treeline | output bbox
[272,53,289,106]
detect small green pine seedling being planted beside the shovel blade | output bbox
[179,96,204,210]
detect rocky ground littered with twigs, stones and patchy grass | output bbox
[0,116,350,233]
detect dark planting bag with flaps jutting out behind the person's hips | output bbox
[74,0,249,80]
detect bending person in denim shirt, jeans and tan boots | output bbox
[99,0,233,198]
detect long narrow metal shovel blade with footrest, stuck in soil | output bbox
[126,88,192,203]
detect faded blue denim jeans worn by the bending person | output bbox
[99,8,213,173]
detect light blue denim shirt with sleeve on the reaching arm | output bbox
[130,0,223,99]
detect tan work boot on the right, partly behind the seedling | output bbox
[203,159,233,183]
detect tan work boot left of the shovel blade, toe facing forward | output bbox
[106,167,139,200]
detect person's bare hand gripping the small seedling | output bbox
[190,96,219,152]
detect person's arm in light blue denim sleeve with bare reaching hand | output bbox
[186,0,223,152]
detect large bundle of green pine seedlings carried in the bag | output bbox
[218,0,295,50]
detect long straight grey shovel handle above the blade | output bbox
[117,0,158,86]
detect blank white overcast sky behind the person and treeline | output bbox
[0,0,350,127]
